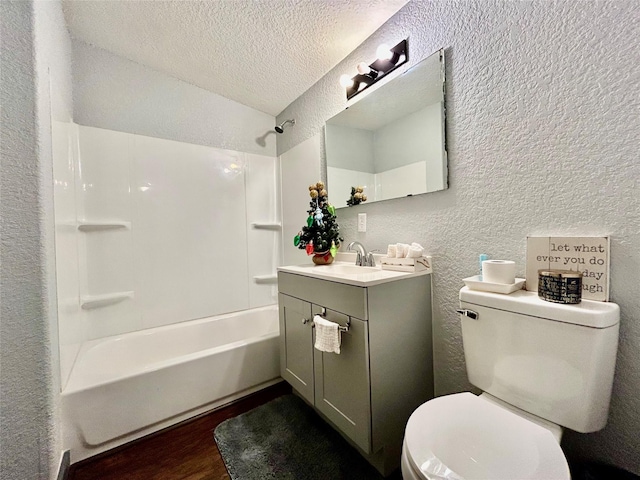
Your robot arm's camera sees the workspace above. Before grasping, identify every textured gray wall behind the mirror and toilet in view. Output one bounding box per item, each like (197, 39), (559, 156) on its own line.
(278, 1), (640, 474)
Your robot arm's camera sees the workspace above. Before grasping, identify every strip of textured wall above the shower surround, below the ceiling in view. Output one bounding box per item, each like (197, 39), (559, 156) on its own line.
(73, 40), (276, 156)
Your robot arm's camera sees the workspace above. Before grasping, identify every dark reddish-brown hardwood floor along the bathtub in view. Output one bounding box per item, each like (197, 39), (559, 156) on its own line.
(69, 382), (291, 480)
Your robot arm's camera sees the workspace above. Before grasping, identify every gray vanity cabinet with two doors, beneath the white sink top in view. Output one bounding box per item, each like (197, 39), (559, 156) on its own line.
(278, 271), (433, 475)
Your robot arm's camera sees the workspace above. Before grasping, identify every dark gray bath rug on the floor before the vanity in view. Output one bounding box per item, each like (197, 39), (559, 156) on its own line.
(214, 395), (382, 480)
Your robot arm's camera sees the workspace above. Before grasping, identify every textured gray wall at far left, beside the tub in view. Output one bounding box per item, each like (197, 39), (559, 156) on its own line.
(0, 2), (71, 480)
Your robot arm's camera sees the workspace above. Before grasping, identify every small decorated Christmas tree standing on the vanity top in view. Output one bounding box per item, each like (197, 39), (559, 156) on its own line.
(293, 182), (342, 260)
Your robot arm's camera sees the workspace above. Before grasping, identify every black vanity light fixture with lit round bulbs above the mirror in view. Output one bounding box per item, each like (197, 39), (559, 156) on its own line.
(340, 39), (409, 100)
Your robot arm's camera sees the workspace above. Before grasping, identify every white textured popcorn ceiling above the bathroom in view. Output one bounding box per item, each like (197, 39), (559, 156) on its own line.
(63, 0), (408, 115)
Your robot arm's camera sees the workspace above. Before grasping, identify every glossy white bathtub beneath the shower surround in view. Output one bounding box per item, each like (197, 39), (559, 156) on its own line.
(62, 305), (280, 462)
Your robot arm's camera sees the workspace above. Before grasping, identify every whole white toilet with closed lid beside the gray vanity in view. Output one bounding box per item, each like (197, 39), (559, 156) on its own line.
(402, 287), (620, 480)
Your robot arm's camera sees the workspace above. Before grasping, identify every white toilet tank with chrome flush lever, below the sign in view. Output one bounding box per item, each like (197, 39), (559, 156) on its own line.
(460, 287), (620, 433)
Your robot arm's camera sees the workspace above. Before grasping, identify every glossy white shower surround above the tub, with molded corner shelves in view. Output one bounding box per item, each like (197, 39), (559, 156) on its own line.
(53, 123), (282, 388)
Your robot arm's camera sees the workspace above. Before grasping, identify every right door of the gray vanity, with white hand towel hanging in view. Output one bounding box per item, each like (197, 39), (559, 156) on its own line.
(313, 305), (371, 453)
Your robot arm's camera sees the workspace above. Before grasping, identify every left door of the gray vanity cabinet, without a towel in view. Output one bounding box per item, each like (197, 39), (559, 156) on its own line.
(278, 294), (313, 404)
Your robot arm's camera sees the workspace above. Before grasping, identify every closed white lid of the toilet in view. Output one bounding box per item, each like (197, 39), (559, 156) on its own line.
(405, 392), (571, 480)
